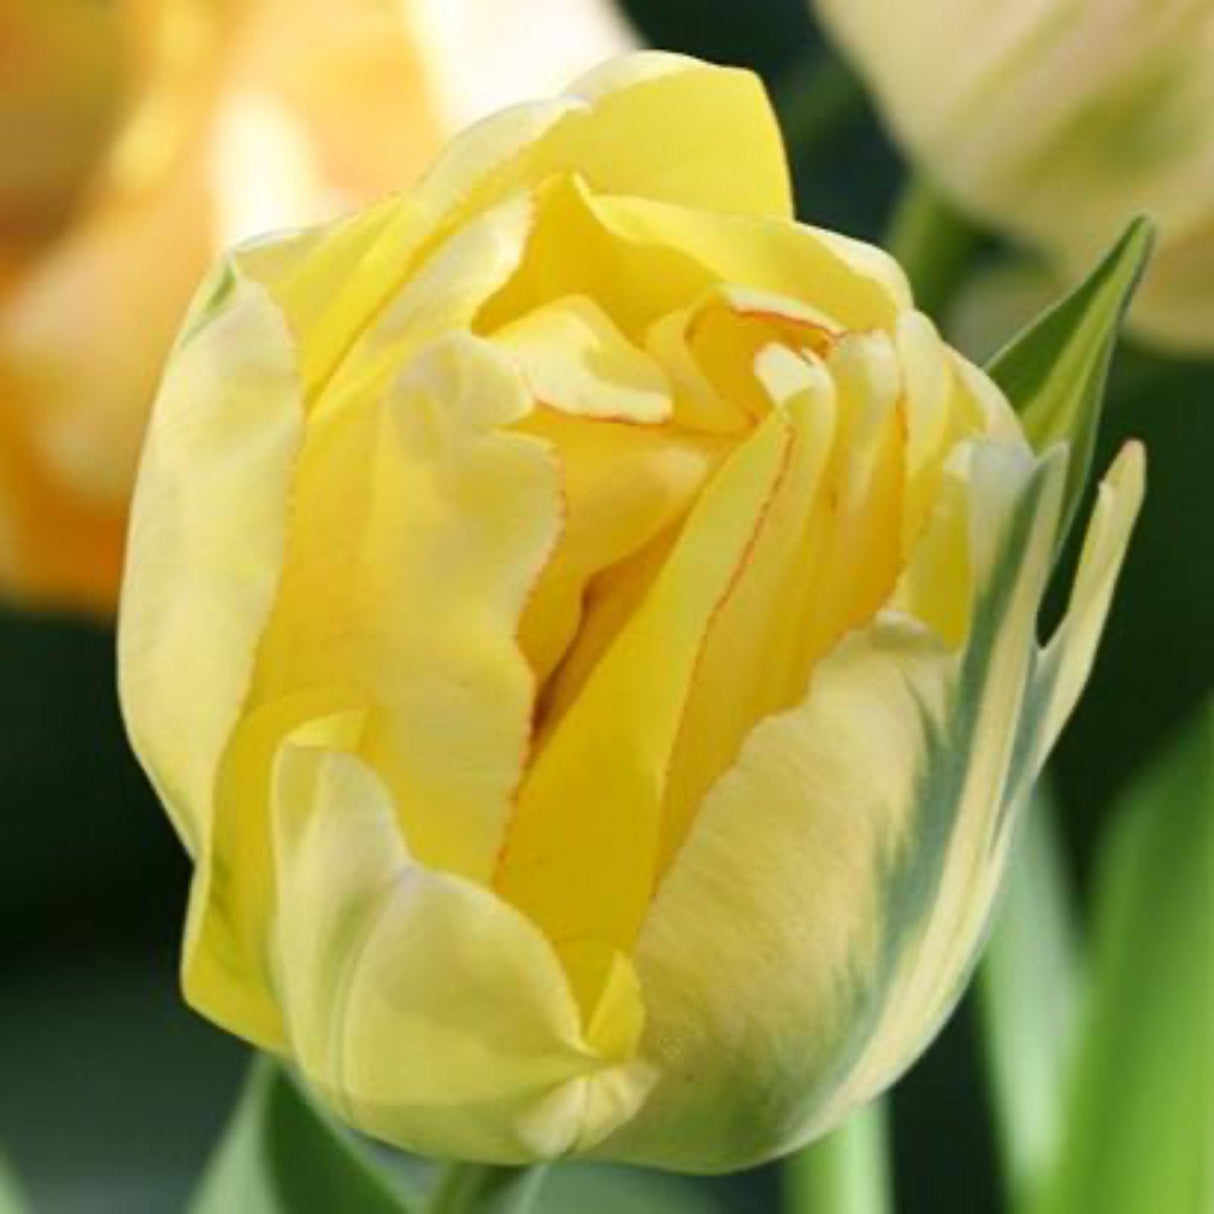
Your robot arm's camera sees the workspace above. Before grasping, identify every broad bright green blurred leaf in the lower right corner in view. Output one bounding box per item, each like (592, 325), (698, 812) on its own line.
(1037, 700), (1214, 1214)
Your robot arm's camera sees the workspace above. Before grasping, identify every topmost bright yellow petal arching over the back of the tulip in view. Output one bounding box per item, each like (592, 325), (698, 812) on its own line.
(269, 52), (792, 390)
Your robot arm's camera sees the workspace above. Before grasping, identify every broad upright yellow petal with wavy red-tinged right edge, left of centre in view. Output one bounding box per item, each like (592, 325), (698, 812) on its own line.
(242, 336), (561, 880)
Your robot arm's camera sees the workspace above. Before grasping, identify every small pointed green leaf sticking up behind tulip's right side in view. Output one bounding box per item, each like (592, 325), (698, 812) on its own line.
(987, 217), (1155, 544)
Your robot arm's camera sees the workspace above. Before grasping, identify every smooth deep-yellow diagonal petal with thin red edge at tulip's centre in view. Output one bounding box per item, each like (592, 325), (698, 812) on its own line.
(494, 413), (790, 1015)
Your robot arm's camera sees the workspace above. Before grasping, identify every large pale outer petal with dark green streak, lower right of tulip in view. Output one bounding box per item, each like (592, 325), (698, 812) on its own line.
(601, 444), (1063, 1170)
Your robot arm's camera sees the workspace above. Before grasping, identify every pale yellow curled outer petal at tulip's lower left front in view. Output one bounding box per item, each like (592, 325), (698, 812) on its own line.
(272, 725), (649, 1163)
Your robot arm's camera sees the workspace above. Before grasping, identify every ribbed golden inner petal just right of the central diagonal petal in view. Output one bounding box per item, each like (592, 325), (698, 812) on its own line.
(658, 334), (903, 878)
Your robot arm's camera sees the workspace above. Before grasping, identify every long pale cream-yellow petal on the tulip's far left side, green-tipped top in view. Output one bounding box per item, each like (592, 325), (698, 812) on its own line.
(118, 260), (304, 852)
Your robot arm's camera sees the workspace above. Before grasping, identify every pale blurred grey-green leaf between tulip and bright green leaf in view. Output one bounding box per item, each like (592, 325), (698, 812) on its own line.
(978, 789), (1082, 1208)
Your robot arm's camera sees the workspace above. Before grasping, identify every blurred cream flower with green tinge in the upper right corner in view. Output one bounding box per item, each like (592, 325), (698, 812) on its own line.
(816, 0), (1214, 353)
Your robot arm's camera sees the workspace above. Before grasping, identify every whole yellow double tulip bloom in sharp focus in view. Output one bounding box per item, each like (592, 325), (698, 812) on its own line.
(120, 53), (1142, 1170)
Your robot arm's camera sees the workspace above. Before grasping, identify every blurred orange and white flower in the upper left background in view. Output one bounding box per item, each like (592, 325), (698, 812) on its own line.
(0, 0), (631, 611)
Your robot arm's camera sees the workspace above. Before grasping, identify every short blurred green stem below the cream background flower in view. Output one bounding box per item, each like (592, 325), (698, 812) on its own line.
(885, 176), (982, 322)
